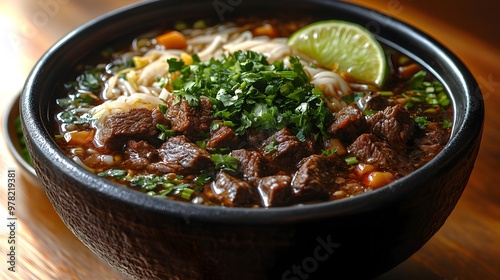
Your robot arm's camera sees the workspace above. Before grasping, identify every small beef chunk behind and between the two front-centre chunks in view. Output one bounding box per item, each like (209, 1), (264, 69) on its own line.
(231, 149), (266, 183)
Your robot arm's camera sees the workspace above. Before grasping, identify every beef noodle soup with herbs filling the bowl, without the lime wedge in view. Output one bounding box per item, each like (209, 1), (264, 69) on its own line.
(54, 18), (453, 207)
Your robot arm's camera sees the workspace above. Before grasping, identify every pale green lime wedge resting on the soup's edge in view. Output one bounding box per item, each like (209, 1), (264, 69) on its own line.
(288, 20), (386, 87)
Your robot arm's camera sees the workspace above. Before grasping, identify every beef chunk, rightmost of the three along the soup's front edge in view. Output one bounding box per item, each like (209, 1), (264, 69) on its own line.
(291, 154), (346, 202)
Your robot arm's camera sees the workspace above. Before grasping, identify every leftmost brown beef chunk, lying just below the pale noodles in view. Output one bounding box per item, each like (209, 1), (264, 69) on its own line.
(101, 109), (168, 151)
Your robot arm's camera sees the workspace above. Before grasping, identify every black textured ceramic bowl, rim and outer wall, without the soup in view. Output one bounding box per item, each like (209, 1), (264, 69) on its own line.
(21, 0), (484, 279)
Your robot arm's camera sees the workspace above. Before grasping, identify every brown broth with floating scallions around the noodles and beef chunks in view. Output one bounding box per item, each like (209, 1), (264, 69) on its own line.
(54, 18), (453, 207)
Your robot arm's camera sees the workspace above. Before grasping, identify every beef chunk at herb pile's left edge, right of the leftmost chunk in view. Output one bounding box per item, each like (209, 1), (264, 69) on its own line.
(165, 98), (212, 141)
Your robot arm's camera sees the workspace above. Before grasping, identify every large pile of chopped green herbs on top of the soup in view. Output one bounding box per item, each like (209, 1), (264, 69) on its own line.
(168, 51), (333, 141)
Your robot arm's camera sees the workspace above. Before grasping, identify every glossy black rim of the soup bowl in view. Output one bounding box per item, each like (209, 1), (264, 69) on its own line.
(21, 0), (484, 224)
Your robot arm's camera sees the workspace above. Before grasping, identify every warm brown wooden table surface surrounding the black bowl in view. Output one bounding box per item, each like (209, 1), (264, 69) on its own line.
(0, 0), (500, 280)
